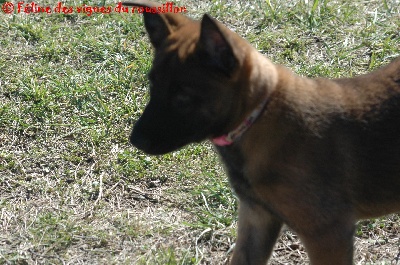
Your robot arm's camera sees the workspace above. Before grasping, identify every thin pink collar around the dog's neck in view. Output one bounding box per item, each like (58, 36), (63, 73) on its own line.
(211, 99), (268, 146)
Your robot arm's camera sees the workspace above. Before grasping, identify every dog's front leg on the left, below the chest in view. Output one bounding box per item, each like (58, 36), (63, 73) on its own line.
(230, 200), (282, 265)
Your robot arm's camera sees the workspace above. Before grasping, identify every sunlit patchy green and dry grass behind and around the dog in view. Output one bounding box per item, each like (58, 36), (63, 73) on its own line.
(0, 0), (400, 264)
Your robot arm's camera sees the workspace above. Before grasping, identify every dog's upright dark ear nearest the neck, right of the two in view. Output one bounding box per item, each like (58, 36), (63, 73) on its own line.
(199, 14), (238, 76)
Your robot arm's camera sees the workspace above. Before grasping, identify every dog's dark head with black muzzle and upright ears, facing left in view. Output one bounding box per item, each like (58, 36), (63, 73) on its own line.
(123, 1), (260, 154)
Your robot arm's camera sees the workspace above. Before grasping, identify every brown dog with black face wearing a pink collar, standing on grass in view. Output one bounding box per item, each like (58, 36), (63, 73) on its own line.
(123, 1), (400, 265)
